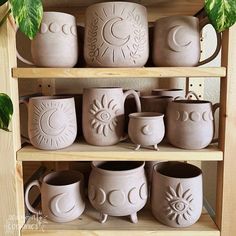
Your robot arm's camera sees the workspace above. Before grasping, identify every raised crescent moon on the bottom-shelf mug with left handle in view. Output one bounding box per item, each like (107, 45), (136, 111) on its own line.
(50, 193), (76, 218)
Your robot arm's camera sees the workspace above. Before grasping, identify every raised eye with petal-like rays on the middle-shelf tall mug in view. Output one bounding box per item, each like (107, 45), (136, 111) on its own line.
(90, 95), (119, 136)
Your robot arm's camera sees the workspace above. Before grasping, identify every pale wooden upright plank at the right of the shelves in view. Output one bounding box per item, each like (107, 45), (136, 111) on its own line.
(216, 25), (236, 236)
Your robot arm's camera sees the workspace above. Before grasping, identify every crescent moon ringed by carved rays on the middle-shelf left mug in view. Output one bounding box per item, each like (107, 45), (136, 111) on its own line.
(39, 109), (66, 136)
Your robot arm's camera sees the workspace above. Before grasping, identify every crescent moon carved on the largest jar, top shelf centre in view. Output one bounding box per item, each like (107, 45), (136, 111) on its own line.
(103, 17), (130, 46)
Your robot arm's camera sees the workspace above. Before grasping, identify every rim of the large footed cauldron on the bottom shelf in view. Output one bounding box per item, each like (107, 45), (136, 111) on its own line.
(91, 161), (145, 176)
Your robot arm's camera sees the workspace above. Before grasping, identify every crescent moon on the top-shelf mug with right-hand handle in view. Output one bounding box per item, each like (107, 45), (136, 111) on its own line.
(167, 25), (192, 52)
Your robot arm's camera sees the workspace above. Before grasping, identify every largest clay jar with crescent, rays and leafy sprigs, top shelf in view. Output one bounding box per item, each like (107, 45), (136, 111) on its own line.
(84, 2), (149, 67)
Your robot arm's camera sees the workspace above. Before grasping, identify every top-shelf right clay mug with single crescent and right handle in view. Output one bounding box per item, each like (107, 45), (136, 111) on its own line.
(153, 16), (221, 66)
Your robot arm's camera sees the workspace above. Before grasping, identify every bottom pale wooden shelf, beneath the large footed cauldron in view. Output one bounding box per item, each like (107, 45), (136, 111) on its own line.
(21, 206), (220, 236)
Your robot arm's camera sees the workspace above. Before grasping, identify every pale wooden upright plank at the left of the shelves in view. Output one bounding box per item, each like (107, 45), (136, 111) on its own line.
(0, 4), (24, 236)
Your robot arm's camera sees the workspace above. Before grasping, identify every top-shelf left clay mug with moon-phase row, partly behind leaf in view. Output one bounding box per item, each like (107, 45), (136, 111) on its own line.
(17, 12), (78, 67)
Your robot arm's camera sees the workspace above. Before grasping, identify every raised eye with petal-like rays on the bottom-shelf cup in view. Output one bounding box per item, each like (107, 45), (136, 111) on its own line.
(166, 183), (193, 225)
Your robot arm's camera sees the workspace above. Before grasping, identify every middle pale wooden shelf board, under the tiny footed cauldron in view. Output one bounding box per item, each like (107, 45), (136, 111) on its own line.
(17, 142), (223, 161)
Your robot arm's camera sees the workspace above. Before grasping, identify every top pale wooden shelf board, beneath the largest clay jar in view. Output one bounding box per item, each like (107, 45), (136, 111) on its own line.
(12, 67), (226, 79)
